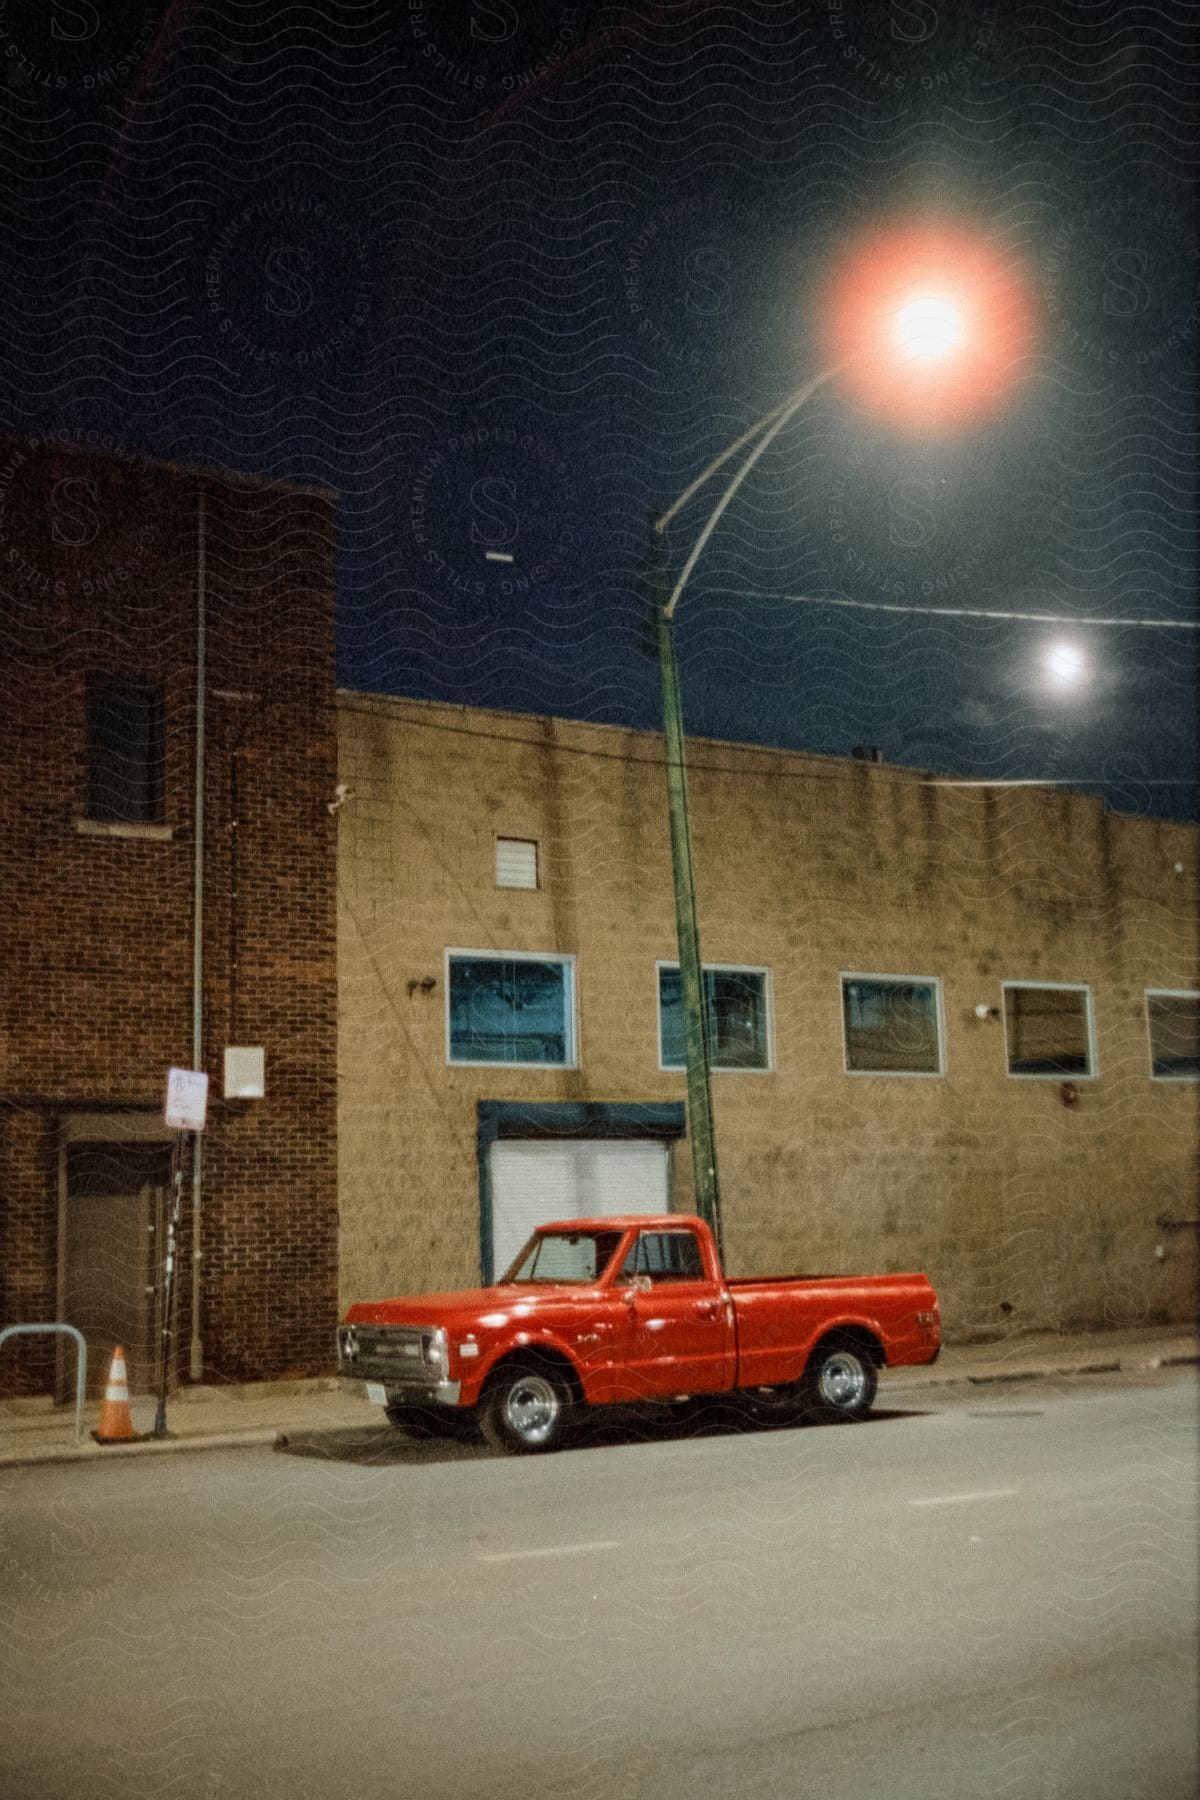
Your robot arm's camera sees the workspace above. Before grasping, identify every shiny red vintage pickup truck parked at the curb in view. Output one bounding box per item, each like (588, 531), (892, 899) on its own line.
(338, 1213), (941, 1453)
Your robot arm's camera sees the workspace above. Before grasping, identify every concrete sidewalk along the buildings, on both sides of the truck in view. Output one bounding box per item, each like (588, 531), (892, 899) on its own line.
(0, 1327), (1200, 1469)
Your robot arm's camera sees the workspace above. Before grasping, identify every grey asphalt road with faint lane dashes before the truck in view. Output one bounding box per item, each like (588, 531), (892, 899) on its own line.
(0, 1372), (1200, 1800)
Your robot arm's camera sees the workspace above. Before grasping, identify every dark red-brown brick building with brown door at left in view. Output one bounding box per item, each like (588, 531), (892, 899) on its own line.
(0, 441), (336, 1391)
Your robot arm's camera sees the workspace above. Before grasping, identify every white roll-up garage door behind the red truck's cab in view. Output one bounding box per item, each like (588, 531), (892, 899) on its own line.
(486, 1138), (669, 1280)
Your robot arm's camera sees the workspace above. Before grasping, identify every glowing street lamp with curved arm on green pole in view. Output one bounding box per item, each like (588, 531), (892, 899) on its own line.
(648, 223), (1031, 1247)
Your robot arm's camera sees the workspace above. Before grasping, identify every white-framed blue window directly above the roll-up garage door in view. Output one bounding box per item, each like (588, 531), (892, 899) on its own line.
(446, 950), (576, 1069)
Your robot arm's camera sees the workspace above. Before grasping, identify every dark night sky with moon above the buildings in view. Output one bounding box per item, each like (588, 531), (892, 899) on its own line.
(0, 0), (1196, 817)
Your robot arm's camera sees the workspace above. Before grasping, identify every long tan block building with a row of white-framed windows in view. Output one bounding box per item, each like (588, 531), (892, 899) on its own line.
(338, 693), (1200, 1337)
